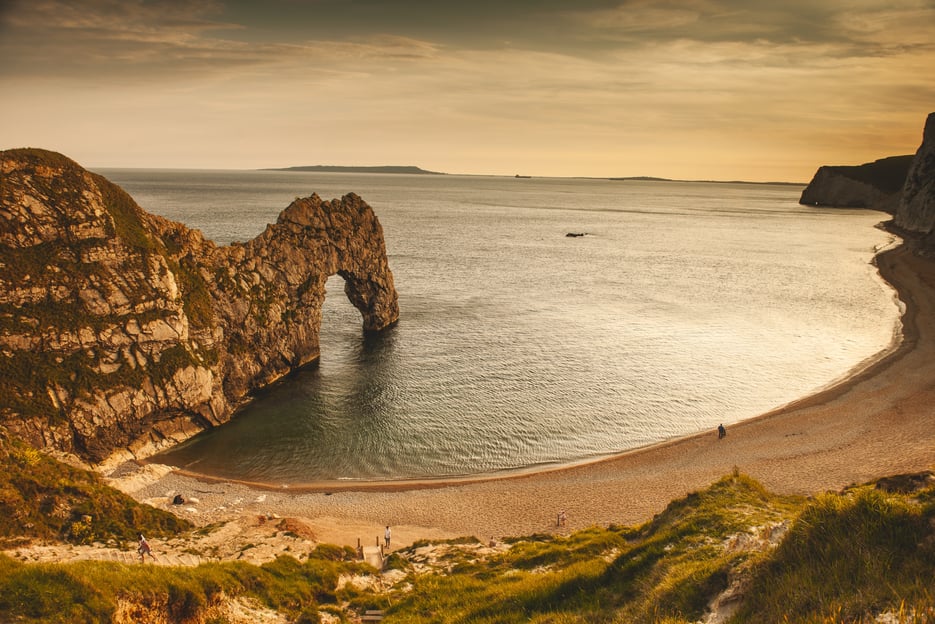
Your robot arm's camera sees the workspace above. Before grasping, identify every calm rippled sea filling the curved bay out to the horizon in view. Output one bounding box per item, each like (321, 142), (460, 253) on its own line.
(100, 169), (900, 487)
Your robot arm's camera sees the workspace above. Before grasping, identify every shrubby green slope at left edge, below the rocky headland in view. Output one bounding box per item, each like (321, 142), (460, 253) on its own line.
(0, 436), (191, 545)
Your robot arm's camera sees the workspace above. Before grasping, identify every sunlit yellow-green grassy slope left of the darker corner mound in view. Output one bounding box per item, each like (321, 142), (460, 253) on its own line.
(386, 474), (801, 624)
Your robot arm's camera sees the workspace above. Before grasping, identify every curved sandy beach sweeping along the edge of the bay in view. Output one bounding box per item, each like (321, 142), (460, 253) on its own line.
(119, 234), (935, 547)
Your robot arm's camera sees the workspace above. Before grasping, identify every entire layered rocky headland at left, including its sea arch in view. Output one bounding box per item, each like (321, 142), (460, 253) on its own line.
(0, 149), (399, 463)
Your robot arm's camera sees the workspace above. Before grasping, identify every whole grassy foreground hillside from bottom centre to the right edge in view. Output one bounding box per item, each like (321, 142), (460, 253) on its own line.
(374, 472), (935, 624)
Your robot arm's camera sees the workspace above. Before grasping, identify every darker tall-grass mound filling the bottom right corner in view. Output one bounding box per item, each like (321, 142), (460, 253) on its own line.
(735, 486), (935, 622)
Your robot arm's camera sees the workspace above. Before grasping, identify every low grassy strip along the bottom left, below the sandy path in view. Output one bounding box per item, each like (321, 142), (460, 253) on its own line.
(0, 553), (376, 624)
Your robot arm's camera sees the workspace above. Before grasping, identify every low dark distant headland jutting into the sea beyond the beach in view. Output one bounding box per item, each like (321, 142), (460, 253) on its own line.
(799, 155), (912, 214)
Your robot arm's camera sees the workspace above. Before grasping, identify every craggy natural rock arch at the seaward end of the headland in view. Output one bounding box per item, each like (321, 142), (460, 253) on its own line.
(219, 193), (399, 398)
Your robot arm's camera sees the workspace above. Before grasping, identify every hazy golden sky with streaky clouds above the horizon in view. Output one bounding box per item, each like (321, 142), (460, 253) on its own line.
(0, 0), (935, 182)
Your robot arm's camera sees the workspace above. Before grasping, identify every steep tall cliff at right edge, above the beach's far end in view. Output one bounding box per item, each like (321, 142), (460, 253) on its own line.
(894, 113), (935, 235)
